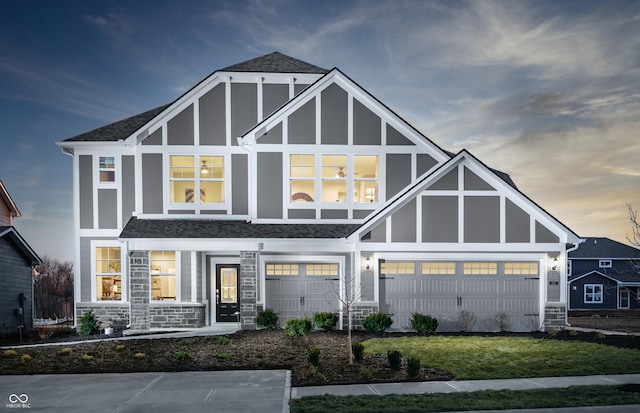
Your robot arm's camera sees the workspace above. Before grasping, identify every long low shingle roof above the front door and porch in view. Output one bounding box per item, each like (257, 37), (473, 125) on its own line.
(120, 217), (359, 239)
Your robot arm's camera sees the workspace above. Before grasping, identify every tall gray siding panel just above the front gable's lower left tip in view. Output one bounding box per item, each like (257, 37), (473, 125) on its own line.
(231, 83), (258, 145)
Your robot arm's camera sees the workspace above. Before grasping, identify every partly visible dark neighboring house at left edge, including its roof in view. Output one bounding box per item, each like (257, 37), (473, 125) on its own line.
(0, 181), (42, 334)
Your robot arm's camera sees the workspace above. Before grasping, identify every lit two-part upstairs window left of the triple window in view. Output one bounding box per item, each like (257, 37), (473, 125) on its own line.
(169, 155), (225, 204)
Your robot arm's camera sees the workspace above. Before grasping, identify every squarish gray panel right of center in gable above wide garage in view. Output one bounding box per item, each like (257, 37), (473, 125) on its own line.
(464, 196), (500, 242)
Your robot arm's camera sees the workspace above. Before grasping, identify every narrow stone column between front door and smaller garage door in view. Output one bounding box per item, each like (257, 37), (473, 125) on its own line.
(240, 251), (258, 330)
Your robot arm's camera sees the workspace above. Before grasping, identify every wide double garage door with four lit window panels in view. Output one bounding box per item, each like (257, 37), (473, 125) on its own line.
(380, 261), (539, 331)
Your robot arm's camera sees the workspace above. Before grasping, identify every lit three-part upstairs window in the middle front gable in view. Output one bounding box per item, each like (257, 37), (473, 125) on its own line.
(289, 154), (380, 203)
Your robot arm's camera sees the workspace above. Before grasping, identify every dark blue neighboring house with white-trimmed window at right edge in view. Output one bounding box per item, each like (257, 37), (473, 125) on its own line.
(567, 238), (640, 310)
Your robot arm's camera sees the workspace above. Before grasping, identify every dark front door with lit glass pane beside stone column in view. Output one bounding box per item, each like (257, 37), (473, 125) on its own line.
(216, 264), (240, 323)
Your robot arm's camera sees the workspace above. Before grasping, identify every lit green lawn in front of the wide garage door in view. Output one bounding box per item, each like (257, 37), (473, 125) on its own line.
(364, 336), (640, 380)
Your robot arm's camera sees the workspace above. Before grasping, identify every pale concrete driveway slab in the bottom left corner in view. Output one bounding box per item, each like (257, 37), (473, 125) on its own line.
(0, 370), (291, 413)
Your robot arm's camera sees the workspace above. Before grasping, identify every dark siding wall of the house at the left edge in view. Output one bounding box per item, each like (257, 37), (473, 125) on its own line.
(0, 235), (33, 334)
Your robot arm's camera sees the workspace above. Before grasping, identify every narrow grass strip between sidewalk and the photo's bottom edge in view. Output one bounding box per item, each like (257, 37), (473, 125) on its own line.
(290, 386), (640, 413)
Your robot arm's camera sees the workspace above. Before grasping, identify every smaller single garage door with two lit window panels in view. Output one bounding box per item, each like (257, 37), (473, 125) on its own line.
(265, 263), (340, 325)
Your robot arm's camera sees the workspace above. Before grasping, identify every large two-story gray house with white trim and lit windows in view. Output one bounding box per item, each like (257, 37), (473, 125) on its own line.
(58, 52), (580, 331)
